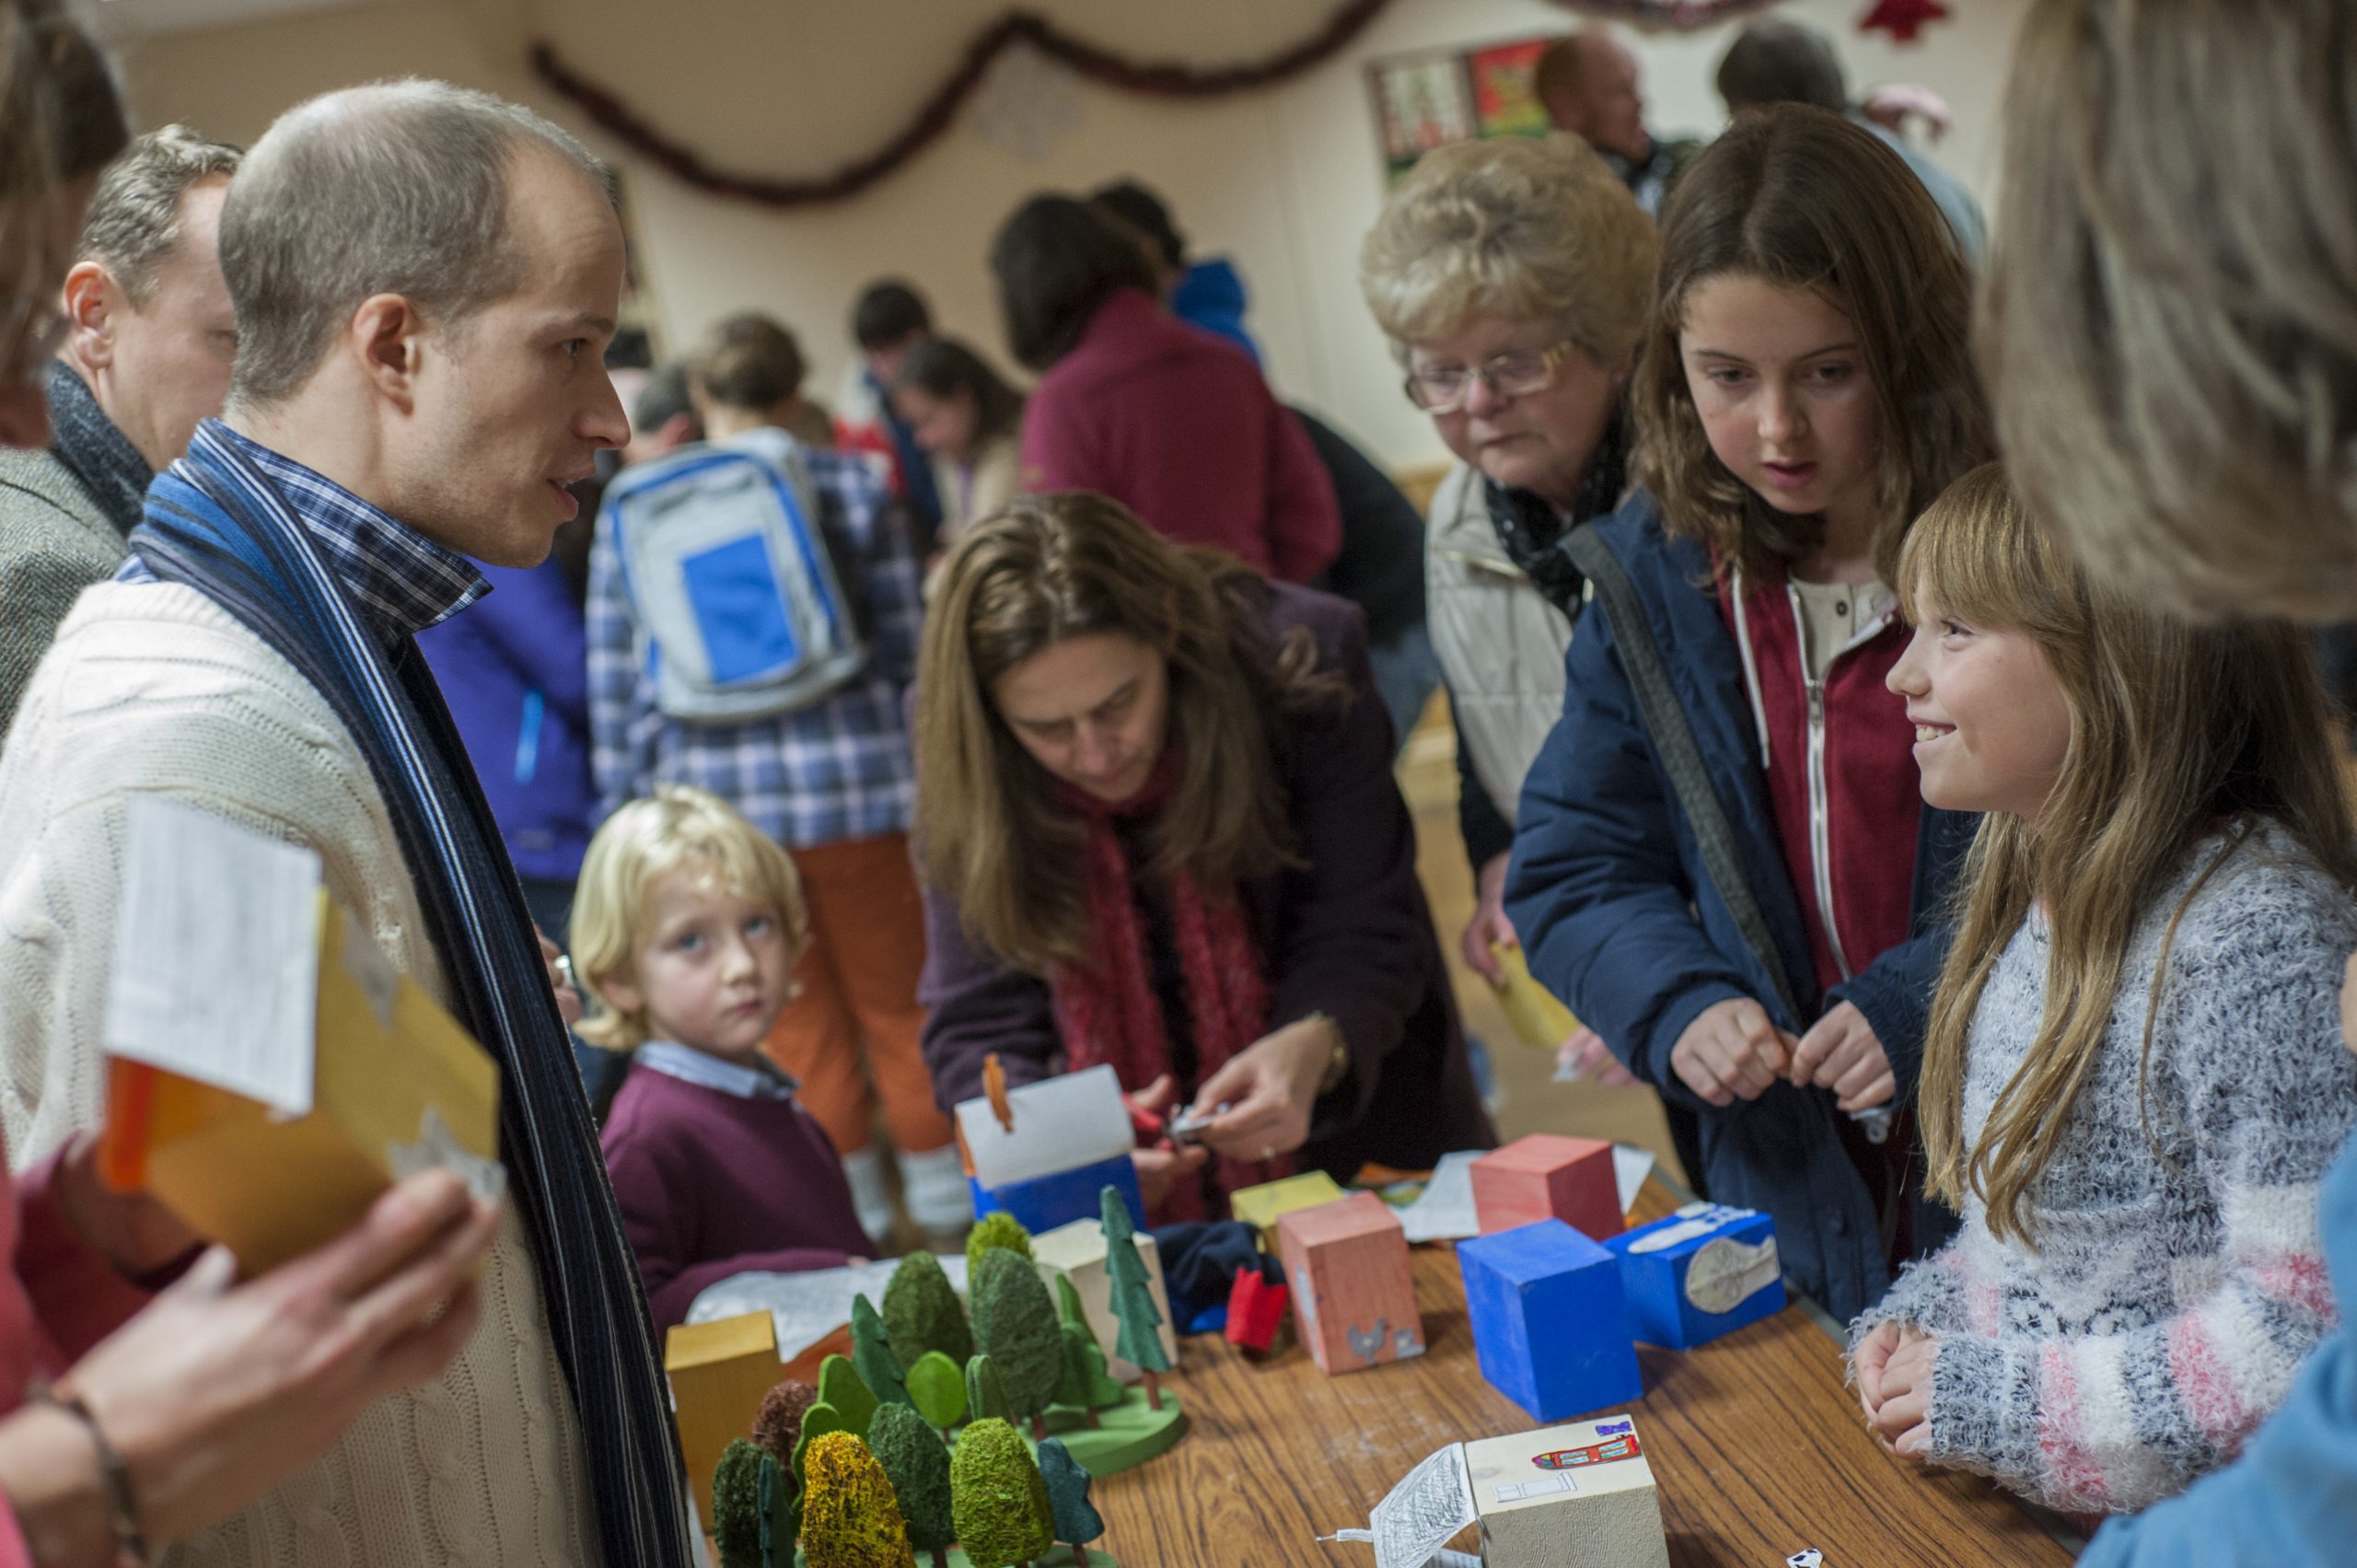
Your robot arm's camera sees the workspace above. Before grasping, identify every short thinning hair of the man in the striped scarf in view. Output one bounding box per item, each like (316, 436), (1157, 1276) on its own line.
(222, 80), (613, 408)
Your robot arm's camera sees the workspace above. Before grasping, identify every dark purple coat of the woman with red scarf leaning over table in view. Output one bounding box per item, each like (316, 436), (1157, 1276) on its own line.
(917, 585), (1497, 1181)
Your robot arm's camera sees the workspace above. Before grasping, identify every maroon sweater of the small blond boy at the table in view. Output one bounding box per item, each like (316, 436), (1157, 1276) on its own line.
(598, 1066), (875, 1328)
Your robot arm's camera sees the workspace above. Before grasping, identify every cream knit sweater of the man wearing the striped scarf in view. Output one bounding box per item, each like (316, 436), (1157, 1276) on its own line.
(0, 583), (598, 1568)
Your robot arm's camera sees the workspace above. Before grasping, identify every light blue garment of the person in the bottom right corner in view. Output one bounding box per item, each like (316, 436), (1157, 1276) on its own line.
(2079, 1144), (2357, 1568)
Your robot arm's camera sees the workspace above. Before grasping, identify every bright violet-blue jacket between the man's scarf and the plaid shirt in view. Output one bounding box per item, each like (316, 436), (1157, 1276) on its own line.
(417, 559), (597, 882)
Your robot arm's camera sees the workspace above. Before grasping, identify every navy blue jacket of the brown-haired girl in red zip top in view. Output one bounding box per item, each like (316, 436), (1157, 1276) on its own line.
(1506, 491), (1978, 1320)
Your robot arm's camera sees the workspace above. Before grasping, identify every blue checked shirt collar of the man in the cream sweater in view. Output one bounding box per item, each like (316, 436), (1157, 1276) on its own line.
(121, 420), (490, 646)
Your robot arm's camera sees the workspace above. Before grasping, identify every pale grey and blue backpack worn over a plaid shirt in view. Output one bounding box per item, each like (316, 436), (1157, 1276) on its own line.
(601, 429), (867, 724)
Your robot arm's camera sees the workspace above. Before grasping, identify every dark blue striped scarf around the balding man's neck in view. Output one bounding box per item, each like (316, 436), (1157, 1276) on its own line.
(132, 422), (695, 1568)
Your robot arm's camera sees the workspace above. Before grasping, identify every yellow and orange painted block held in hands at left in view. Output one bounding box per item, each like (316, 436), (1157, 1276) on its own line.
(109, 894), (502, 1273)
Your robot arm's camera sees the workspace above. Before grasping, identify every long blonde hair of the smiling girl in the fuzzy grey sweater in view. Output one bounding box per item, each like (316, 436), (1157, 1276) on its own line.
(1893, 464), (2357, 1240)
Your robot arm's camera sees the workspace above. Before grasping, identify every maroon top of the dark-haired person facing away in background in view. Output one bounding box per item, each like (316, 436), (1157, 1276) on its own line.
(1023, 287), (1341, 583)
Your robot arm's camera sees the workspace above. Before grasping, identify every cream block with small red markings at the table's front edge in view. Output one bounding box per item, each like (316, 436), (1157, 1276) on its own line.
(1466, 1415), (1668, 1568)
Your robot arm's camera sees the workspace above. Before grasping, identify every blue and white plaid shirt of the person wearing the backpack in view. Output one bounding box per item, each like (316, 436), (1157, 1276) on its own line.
(586, 450), (924, 849)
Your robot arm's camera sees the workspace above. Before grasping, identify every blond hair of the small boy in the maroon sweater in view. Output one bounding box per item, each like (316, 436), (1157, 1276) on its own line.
(573, 785), (811, 1051)
